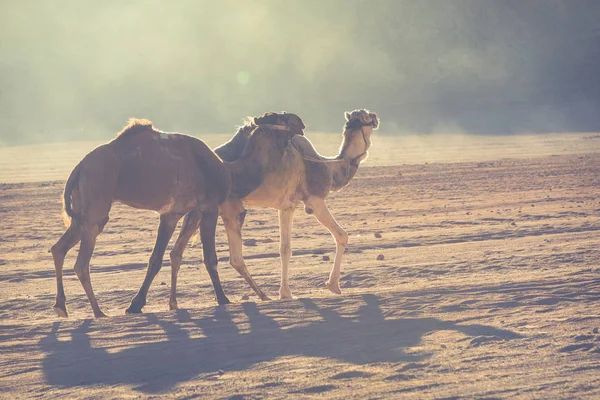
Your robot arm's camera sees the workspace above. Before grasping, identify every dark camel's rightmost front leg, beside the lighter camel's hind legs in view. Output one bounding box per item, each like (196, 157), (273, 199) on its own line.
(200, 210), (231, 304)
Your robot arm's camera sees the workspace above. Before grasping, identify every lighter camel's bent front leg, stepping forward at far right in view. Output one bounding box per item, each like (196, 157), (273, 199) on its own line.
(306, 197), (348, 294)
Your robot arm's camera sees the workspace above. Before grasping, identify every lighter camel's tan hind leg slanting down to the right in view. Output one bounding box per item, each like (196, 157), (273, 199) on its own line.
(220, 201), (270, 300)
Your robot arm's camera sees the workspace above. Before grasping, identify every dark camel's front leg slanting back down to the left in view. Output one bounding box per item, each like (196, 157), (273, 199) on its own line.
(125, 214), (181, 314)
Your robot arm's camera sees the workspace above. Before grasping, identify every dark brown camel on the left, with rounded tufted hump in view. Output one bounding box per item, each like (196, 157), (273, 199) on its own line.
(50, 114), (304, 318)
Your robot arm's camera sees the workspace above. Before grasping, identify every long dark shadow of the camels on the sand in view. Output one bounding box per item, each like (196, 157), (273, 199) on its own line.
(40, 295), (520, 393)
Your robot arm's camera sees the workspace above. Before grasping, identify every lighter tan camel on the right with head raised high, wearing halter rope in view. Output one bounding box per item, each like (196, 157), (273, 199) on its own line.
(169, 110), (379, 309)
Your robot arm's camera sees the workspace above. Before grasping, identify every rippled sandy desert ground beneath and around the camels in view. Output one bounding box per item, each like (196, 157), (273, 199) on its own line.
(0, 134), (600, 399)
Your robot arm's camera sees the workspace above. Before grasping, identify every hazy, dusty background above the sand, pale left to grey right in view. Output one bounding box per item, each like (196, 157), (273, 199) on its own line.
(0, 0), (600, 144)
